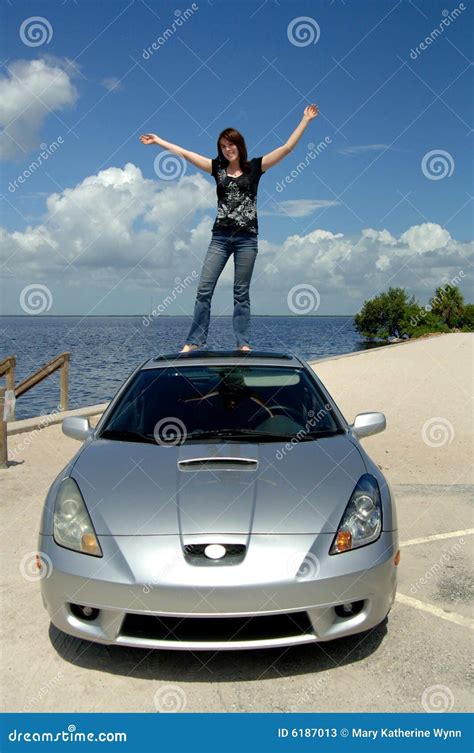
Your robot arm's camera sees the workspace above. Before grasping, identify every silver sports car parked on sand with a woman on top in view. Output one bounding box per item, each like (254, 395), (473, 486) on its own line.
(37, 350), (399, 651)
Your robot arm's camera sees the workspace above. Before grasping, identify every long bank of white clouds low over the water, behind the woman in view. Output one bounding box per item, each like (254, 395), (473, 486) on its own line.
(0, 162), (473, 314)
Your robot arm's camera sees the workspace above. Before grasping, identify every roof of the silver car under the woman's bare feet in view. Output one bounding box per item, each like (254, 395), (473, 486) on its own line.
(142, 350), (305, 369)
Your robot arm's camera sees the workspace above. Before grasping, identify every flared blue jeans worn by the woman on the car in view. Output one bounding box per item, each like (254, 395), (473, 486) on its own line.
(186, 231), (258, 348)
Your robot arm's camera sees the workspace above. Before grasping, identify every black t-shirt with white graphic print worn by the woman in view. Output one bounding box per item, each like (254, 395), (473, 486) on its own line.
(212, 157), (265, 235)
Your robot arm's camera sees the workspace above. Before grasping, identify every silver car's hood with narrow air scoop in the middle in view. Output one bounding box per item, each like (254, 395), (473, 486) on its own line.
(71, 434), (366, 536)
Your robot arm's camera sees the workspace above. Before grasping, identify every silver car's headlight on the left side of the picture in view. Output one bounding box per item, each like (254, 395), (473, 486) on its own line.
(53, 478), (102, 557)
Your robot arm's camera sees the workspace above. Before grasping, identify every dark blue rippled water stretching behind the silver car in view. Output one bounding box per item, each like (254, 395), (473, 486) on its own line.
(0, 316), (376, 419)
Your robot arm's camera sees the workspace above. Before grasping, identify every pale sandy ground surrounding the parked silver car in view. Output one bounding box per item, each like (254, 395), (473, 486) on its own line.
(0, 333), (474, 712)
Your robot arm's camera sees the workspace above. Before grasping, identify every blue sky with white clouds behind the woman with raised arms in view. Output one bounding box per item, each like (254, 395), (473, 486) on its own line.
(0, 0), (473, 315)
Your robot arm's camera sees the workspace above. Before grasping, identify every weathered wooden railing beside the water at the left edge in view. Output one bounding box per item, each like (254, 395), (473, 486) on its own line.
(0, 353), (71, 468)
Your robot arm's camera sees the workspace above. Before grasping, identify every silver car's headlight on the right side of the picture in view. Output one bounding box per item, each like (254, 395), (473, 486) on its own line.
(329, 473), (382, 554)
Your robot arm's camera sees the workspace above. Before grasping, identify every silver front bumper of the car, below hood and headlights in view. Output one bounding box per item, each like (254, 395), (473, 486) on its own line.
(39, 531), (398, 651)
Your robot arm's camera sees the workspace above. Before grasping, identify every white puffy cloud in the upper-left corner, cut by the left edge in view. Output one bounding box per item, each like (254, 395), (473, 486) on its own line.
(0, 60), (78, 159)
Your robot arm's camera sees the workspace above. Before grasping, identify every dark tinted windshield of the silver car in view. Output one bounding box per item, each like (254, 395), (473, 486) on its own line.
(100, 366), (344, 444)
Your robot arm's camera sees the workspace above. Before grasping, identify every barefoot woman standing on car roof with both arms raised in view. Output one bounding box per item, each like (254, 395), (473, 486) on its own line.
(140, 104), (319, 353)
